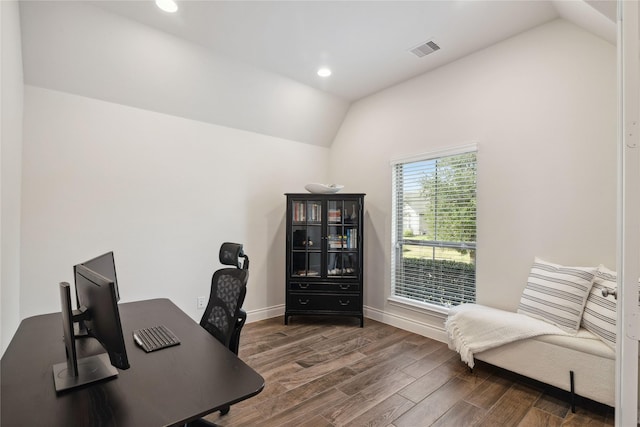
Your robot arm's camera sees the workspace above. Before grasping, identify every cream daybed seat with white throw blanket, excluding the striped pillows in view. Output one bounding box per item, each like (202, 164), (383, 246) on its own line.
(445, 304), (615, 409)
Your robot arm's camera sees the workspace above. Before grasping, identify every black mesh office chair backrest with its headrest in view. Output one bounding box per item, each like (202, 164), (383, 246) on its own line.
(200, 243), (249, 347)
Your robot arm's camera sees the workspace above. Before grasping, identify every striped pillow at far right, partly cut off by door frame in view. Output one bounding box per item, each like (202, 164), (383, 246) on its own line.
(582, 265), (618, 350)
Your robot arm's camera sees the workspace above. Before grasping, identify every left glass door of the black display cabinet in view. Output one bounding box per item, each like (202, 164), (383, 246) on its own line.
(290, 200), (322, 277)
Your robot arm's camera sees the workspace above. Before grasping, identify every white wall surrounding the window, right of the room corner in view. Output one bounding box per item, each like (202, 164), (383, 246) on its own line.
(330, 20), (616, 338)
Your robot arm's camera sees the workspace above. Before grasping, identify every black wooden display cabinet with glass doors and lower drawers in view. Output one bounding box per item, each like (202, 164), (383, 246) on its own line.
(284, 193), (365, 327)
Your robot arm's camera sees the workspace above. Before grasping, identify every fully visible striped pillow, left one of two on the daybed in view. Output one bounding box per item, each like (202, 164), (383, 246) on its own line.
(518, 258), (596, 333)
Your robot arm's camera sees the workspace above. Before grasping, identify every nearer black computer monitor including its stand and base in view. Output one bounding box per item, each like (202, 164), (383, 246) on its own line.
(53, 265), (129, 392)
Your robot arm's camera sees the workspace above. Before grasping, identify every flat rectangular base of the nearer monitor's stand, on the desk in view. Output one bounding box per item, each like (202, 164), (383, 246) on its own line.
(53, 353), (118, 392)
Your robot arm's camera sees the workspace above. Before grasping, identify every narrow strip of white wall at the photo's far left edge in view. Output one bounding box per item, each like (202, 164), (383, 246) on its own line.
(0, 1), (23, 354)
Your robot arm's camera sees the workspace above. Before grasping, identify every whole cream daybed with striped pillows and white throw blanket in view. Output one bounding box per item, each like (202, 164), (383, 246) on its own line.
(445, 257), (640, 412)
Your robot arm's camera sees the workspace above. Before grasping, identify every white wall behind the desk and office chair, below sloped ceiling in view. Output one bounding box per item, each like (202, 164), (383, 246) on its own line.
(20, 85), (328, 320)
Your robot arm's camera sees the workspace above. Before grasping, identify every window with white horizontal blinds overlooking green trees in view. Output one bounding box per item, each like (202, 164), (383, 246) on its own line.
(391, 145), (477, 307)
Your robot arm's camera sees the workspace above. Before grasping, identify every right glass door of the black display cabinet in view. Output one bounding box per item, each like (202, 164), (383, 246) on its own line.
(324, 200), (360, 277)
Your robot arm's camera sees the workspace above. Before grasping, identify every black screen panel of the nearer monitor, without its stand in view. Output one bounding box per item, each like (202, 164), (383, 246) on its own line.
(75, 265), (129, 369)
